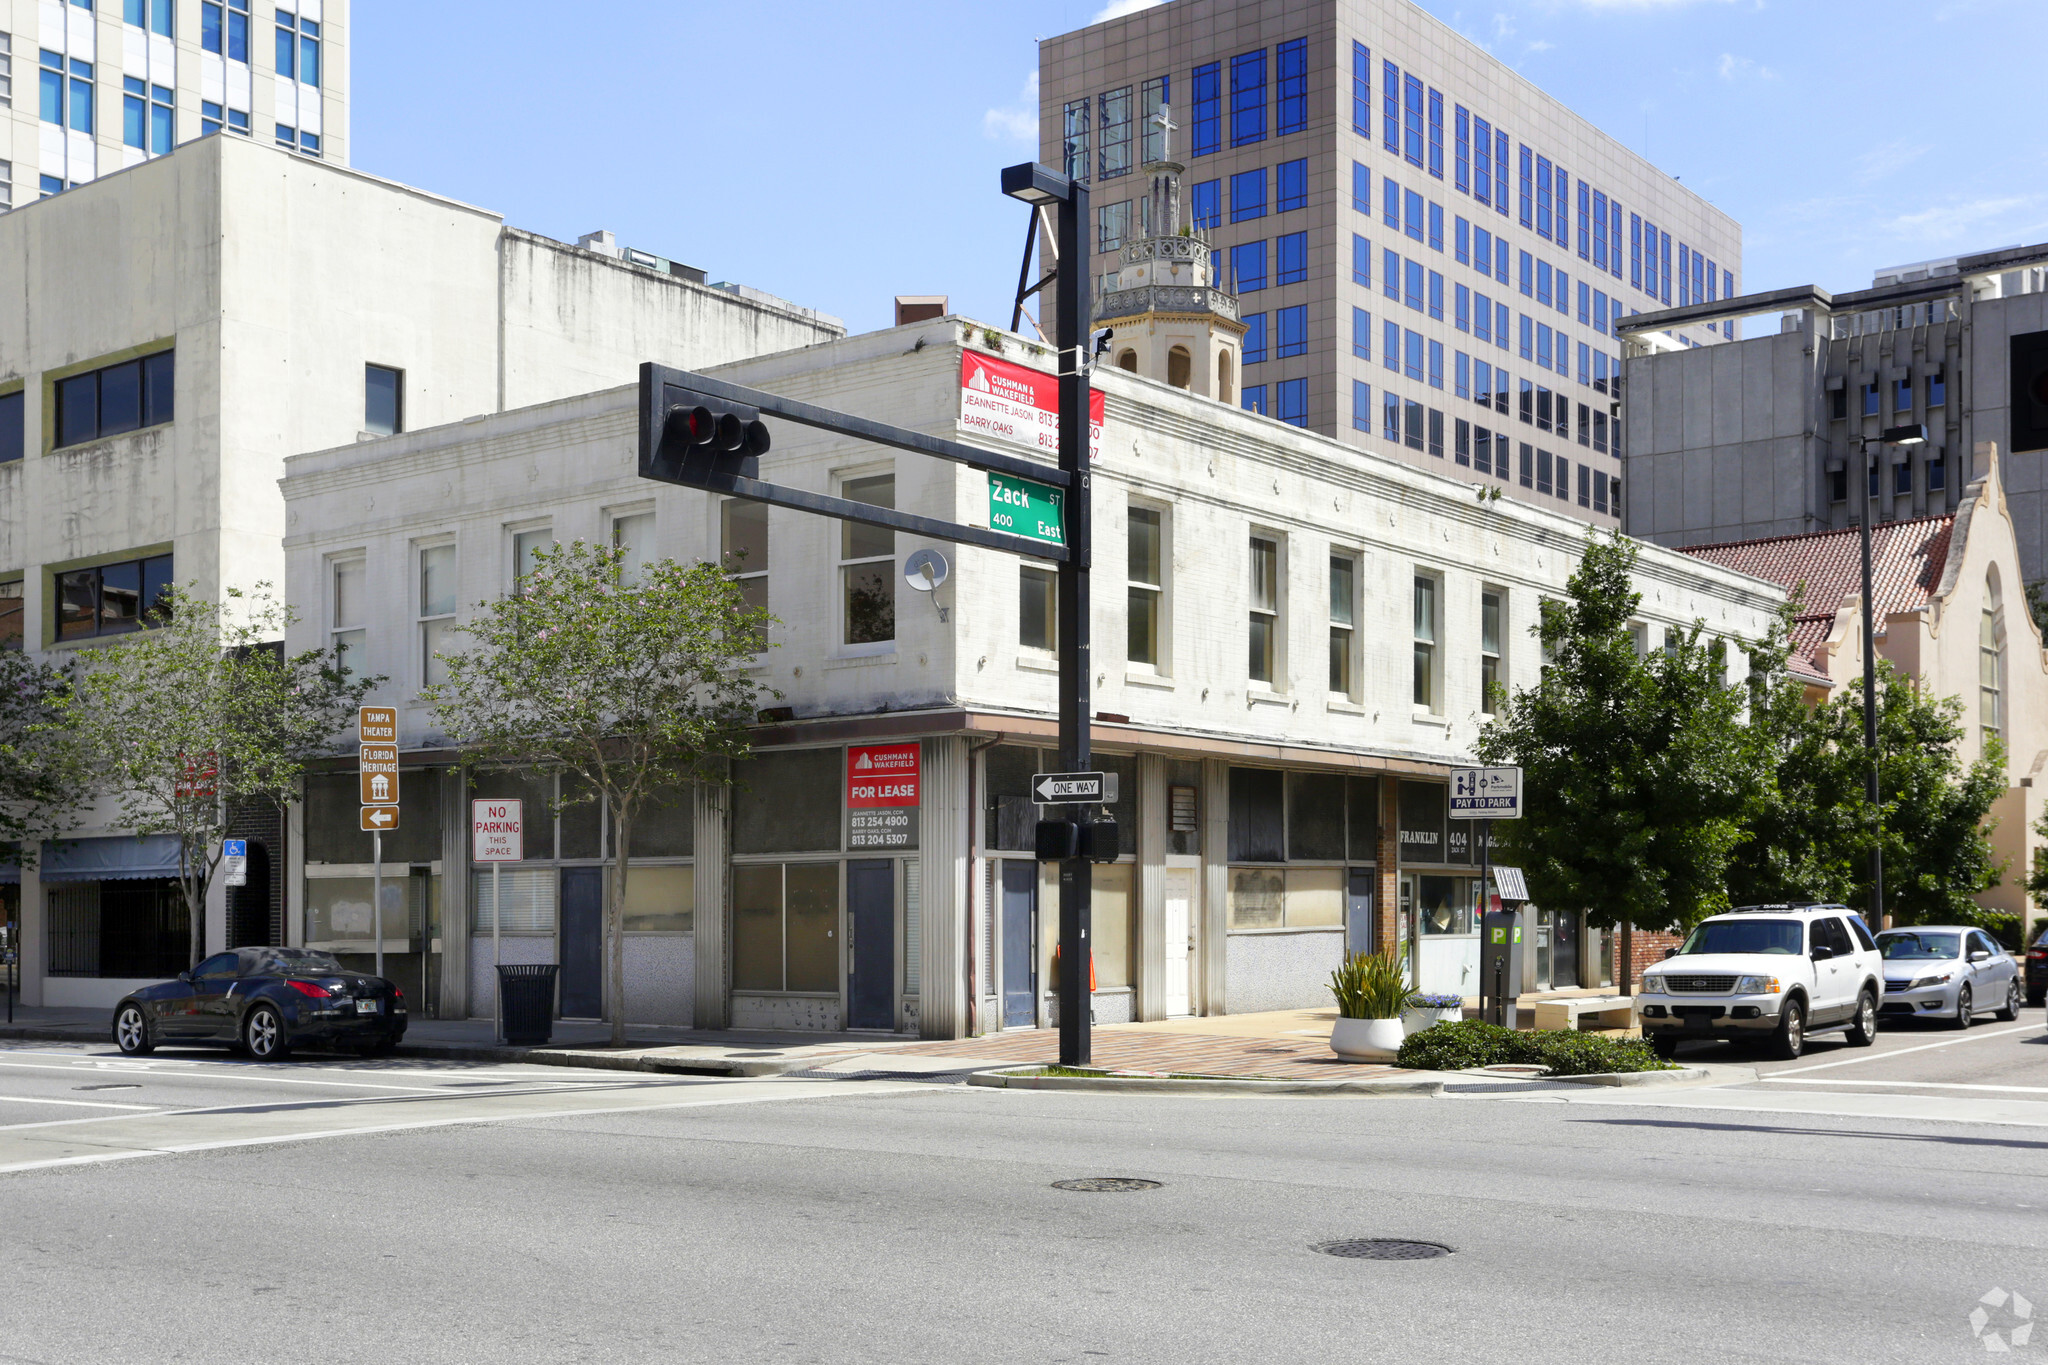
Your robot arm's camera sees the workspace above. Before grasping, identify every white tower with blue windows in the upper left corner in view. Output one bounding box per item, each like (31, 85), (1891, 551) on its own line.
(0, 0), (348, 211)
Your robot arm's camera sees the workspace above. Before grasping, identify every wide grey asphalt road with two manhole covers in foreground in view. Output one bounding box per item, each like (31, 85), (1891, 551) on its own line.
(0, 1035), (2048, 1365)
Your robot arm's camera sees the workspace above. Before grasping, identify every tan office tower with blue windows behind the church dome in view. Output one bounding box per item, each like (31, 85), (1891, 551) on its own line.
(1038, 0), (1743, 526)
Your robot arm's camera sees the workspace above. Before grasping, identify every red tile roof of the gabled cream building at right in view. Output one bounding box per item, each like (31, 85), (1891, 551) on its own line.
(1679, 516), (1956, 677)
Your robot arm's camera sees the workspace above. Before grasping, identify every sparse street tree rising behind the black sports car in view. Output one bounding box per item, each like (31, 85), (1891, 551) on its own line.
(57, 583), (383, 966)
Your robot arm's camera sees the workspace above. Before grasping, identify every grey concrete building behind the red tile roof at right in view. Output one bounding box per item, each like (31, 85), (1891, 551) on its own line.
(1622, 244), (2048, 583)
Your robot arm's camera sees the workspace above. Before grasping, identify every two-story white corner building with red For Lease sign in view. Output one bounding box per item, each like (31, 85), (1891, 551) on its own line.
(283, 317), (1784, 1038)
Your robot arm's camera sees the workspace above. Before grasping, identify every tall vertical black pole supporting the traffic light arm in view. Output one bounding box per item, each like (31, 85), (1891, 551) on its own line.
(1055, 180), (1094, 1066)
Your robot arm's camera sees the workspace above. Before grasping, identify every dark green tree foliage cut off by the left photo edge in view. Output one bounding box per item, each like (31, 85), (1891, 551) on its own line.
(0, 649), (84, 864)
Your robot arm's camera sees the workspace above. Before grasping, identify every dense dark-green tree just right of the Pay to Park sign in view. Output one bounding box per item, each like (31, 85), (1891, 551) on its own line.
(1475, 534), (1757, 929)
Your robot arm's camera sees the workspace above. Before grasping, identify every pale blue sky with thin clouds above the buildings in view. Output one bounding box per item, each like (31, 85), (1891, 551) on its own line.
(350, 0), (2048, 332)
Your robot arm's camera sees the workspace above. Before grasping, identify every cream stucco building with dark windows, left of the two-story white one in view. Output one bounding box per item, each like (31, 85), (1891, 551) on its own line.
(0, 133), (844, 1005)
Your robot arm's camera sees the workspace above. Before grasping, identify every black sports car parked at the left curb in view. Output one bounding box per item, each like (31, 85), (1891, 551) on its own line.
(115, 948), (406, 1062)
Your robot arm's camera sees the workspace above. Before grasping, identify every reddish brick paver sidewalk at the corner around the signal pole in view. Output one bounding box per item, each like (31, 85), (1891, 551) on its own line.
(889, 1025), (1407, 1081)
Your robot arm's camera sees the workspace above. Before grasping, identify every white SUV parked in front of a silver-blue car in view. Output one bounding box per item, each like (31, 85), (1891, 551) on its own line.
(1636, 905), (1884, 1058)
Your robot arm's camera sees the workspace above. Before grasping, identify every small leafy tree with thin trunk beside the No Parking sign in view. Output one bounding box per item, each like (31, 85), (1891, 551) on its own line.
(422, 540), (772, 1044)
